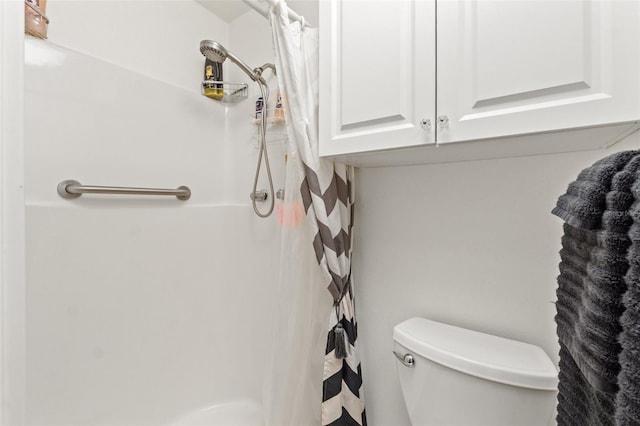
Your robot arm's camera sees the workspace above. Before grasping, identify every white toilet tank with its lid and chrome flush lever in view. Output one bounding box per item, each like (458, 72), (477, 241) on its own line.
(393, 318), (558, 426)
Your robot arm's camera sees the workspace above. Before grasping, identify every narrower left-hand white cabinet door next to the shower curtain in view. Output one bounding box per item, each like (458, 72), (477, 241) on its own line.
(319, 0), (435, 156)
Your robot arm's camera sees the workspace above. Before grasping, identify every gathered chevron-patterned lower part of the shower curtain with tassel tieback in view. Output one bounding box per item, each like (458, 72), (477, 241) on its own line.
(300, 161), (367, 426)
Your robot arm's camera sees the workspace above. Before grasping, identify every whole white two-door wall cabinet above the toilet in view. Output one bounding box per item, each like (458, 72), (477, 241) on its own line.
(319, 0), (640, 164)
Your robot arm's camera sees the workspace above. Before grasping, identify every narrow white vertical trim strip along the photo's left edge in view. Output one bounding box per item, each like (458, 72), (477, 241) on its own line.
(0, 2), (25, 424)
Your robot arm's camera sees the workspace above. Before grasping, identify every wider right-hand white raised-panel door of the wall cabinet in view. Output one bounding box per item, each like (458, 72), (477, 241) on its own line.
(436, 0), (640, 142)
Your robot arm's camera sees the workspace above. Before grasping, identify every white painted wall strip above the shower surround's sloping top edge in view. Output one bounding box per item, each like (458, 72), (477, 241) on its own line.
(47, 0), (229, 92)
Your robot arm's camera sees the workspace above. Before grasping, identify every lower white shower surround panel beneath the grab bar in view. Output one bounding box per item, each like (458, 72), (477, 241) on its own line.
(27, 205), (278, 425)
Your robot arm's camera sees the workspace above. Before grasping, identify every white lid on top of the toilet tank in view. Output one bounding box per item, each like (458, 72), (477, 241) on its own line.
(393, 318), (558, 390)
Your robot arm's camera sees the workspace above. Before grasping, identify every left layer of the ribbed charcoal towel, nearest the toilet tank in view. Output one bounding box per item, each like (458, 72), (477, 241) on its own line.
(553, 151), (640, 425)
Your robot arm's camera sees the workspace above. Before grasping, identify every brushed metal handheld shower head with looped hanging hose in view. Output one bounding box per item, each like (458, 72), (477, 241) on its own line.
(200, 40), (276, 218)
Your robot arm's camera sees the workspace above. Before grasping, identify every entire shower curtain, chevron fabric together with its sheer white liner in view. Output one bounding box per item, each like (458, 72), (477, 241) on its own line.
(265, 0), (366, 426)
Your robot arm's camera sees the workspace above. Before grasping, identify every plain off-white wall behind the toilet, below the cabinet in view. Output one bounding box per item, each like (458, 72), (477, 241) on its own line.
(354, 133), (640, 426)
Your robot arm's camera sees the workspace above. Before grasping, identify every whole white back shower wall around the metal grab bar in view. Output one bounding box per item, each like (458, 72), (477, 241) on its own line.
(25, 0), (281, 425)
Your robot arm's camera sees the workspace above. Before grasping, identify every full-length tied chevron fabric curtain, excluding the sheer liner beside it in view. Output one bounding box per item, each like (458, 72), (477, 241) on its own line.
(269, 0), (367, 426)
